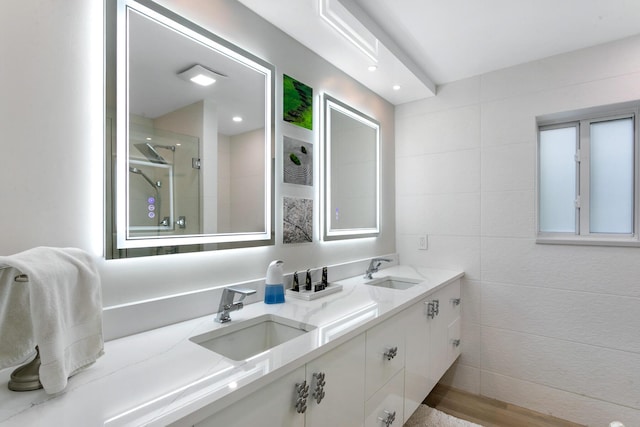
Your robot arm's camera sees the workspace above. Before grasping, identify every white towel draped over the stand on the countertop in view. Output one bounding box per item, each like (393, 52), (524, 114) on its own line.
(0, 247), (104, 394)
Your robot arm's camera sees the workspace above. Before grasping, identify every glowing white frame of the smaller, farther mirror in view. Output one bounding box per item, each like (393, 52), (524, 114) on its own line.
(321, 93), (380, 240)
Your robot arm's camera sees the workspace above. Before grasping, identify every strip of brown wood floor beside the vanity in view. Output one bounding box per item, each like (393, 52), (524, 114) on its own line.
(423, 384), (584, 427)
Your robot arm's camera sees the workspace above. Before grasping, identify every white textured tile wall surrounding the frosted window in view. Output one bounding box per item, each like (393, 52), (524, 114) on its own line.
(396, 37), (640, 426)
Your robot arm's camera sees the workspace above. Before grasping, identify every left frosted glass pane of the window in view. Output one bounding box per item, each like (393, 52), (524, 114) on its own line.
(539, 127), (577, 233)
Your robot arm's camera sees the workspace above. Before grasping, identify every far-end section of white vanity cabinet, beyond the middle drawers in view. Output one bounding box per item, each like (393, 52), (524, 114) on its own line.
(404, 280), (460, 418)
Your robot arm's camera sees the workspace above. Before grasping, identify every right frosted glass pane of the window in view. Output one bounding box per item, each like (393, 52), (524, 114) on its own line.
(589, 118), (633, 234)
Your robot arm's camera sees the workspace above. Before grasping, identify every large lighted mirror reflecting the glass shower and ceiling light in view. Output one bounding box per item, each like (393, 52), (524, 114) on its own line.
(107, 0), (274, 258)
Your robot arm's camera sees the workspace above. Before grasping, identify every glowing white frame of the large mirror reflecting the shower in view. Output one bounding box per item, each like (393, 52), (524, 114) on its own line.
(114, 0), (275, 252)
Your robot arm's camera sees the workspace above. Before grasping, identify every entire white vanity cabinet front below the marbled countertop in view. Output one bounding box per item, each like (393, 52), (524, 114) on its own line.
(186, 280), (460, 427)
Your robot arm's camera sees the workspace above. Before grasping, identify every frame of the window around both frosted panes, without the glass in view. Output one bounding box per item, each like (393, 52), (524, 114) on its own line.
(535, 101), (640, 247)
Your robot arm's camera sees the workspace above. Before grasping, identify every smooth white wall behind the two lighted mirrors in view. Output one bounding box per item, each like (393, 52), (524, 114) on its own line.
(0, 0), (395, 311)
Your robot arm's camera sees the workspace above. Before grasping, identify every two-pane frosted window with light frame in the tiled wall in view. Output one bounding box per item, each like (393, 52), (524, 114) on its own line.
(538, 105), (640, 246)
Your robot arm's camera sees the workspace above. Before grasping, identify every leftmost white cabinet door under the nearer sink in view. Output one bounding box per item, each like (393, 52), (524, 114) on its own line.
(195, 367), (305, 427)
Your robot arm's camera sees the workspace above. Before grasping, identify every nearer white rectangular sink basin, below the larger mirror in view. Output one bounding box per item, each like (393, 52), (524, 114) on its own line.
(190, 314), (316, 361)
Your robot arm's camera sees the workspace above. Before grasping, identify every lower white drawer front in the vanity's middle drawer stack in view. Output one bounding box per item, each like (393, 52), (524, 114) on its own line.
(365, 370), (405, 427)
